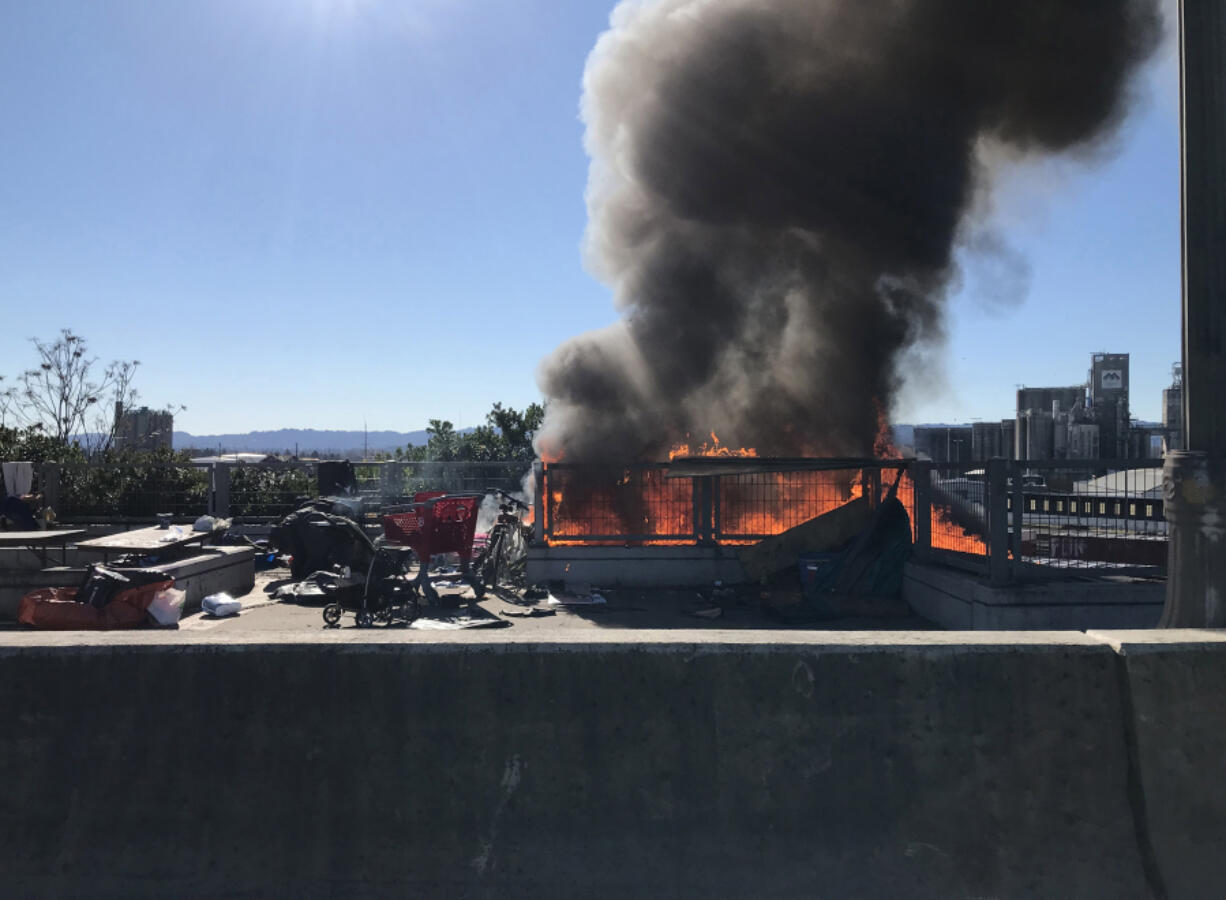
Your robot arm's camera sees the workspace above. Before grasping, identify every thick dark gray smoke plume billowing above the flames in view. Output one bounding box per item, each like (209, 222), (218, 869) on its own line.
(538, 0), (1161, 461)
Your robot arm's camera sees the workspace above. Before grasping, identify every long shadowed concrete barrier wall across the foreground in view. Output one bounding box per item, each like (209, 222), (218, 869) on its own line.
(0, 633), (1226, 900)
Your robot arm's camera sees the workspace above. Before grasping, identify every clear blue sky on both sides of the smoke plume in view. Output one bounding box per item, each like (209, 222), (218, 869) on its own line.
(0, 0), (1179, 434)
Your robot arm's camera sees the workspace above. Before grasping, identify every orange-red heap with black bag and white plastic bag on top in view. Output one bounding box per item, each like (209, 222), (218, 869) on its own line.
(17, 564), (174, 630)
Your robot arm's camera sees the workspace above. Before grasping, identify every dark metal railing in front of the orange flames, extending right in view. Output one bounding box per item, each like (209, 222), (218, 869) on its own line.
(536, 459), (1167, 585)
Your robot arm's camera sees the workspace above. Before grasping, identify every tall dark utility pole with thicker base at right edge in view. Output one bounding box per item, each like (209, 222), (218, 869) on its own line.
(1162, 0), (1226, 628)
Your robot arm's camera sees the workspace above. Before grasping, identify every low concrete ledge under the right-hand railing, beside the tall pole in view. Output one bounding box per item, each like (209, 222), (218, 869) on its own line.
(902, 560), (1166, 630)
